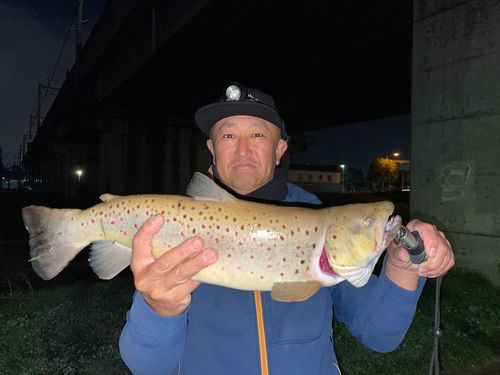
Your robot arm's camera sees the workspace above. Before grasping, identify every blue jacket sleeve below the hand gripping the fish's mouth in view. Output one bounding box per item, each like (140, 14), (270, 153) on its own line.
(330, 259), (426, 353)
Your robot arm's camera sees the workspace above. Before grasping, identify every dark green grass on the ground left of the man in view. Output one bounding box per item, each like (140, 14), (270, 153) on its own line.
(0, 278), (134, 375)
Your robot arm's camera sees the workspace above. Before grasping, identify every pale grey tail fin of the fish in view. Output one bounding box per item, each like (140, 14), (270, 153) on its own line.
(22, 206), (90, 280)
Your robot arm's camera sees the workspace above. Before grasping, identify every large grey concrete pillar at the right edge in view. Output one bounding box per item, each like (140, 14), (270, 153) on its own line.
(411, 0), (500, 284)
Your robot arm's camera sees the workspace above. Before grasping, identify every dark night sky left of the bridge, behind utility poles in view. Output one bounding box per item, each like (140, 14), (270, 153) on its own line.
(0, 0), (106, 167)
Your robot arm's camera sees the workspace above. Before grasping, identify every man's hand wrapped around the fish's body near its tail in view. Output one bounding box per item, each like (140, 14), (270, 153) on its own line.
(130, 215), (217, 317)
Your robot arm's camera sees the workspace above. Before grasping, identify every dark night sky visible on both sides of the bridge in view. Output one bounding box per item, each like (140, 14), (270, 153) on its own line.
(0, 0), (410, 174)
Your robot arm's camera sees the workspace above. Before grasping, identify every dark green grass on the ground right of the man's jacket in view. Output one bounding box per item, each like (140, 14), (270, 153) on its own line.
(334, 269), (500, 375)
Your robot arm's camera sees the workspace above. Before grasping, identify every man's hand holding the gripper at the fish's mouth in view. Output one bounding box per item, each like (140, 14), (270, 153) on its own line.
(385, 220), (455, 290)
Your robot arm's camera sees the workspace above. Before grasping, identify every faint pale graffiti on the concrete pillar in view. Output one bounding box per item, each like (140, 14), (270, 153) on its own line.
(439, 161), (472, 202)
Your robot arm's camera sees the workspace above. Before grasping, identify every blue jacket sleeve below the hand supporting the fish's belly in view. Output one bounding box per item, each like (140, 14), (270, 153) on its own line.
(120, 291), (189, 374)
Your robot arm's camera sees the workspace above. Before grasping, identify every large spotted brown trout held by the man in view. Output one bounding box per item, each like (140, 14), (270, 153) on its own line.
(22, 172), (401, 302)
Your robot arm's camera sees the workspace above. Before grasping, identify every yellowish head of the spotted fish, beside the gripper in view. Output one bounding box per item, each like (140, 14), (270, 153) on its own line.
(325, 201), (401, 287)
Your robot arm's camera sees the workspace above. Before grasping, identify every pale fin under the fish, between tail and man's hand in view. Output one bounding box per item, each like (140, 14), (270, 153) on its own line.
(89, 240), (132, 280)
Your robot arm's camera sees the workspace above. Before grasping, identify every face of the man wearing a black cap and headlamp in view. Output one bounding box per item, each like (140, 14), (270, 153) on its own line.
(207, 116), (288, 195)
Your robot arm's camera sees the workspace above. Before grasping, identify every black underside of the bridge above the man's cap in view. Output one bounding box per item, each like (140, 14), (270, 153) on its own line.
(82, 0), (412, 133)
